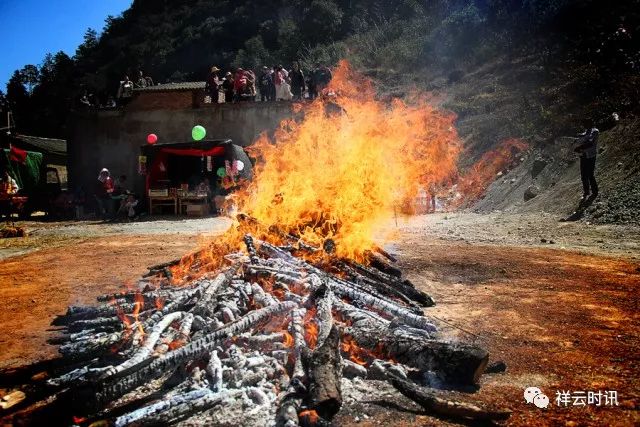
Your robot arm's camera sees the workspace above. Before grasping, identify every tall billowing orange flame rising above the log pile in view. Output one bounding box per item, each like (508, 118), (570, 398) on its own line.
(238, 61), (460, 259)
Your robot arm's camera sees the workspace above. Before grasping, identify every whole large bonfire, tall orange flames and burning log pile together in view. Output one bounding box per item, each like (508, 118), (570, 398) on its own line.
(10, 62), (506, 426)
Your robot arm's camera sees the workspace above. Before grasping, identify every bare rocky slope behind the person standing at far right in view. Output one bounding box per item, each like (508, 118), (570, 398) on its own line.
(474, 118), (640, 224)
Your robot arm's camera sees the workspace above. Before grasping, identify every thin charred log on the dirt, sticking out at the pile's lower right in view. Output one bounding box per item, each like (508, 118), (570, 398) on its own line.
(390, 376), (511, 421)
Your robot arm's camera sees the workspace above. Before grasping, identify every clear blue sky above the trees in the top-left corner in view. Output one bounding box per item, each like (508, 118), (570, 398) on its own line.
(0, 0), (132, 92)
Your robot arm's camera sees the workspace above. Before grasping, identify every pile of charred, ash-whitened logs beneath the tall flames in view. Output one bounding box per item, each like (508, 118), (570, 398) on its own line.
(3, 224), (508, 426)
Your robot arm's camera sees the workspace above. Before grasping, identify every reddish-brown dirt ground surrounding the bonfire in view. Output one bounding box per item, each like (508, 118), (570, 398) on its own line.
(0, 213), (640, 426)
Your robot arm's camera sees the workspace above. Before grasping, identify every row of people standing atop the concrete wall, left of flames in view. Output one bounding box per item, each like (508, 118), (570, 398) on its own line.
(205, 61), (332, 104)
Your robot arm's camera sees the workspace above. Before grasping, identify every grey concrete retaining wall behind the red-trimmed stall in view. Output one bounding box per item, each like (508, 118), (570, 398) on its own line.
(67, 98), (293, 194)
